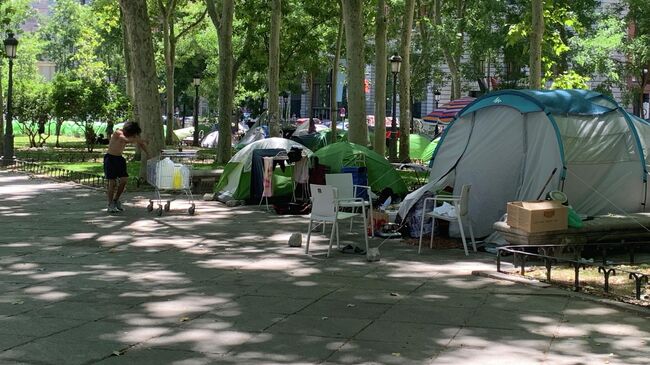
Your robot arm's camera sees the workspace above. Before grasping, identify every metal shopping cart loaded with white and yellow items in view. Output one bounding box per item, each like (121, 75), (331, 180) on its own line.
(147, 150), (197, 216)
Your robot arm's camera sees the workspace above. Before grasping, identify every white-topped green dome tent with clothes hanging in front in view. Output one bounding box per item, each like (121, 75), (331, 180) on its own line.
(215, 138), (312, 202)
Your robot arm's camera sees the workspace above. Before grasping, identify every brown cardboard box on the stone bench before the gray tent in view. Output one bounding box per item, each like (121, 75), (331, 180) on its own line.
(507, 200), (569, 233)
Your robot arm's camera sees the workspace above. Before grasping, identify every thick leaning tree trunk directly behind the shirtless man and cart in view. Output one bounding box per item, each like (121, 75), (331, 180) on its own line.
(120, 0), (164, 178)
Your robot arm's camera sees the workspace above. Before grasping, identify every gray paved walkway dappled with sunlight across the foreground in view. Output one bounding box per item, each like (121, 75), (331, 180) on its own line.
(0, 171), (650, 365)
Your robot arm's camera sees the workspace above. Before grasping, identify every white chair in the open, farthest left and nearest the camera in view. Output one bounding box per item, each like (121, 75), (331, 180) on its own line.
(305, 184), (368, 257)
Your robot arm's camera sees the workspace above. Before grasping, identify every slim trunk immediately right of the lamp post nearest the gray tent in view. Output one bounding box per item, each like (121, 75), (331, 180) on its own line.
(399, 0), (415, 162)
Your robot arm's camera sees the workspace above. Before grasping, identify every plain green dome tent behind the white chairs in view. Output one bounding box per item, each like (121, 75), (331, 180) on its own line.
(314, 142), (407, 195)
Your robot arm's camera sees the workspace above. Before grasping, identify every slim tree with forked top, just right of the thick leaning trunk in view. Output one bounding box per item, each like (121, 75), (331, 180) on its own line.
(157, 0), (207, 144)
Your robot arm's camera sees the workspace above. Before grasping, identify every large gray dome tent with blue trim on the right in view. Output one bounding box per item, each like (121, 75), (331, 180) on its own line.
(400, 90), (650, 236)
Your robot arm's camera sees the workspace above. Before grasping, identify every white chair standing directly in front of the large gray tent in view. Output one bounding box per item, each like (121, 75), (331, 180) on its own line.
(418, 184), (476, 255)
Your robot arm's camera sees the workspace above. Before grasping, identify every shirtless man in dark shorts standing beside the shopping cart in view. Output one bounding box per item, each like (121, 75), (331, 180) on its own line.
(104, 122), (149, 213)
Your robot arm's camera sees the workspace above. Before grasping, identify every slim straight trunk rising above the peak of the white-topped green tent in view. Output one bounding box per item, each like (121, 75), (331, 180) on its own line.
(268, 0), (282, 137)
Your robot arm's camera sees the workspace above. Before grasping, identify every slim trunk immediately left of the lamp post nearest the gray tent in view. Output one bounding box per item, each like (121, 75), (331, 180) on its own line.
(375, 0), (388, 156)
